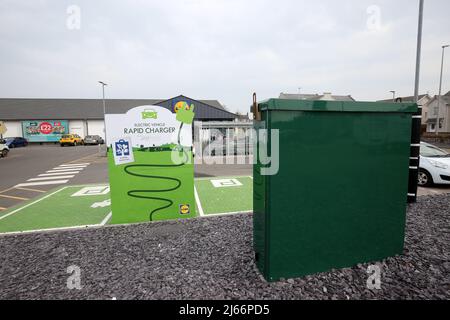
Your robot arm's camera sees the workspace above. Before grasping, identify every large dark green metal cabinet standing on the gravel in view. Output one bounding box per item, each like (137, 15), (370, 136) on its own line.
(253, 99), (418, 281)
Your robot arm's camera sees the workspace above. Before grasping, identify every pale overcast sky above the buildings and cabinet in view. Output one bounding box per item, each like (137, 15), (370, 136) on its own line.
(0, 0), (450, 113)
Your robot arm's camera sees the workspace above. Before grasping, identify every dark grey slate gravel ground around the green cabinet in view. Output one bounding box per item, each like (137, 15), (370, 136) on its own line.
(0, 195), (450, 299)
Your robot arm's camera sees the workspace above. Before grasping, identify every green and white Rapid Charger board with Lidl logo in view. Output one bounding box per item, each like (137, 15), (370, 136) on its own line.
(105, 103), (196, 224)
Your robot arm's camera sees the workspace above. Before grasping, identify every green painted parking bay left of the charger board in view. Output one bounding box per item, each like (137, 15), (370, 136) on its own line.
(0, 185), (111, 233)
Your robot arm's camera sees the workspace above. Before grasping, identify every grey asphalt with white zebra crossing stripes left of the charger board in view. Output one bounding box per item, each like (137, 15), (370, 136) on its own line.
(0, 145), (108, 211)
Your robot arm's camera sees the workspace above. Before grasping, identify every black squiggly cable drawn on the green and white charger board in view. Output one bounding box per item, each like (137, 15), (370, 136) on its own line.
(124, 123), (189, 221)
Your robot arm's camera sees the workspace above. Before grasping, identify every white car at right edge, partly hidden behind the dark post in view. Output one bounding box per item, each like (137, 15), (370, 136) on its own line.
(419, 142), (450, 187)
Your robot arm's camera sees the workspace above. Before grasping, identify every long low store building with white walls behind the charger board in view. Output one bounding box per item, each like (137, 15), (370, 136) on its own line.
(0, 95), (237, 142)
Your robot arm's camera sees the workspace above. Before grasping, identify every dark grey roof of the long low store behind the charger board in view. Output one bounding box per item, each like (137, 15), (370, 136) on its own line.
(0, 95), (236, 120)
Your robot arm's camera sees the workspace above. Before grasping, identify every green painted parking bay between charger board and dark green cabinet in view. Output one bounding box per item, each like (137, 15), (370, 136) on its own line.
(195, 177), (253, 215)
